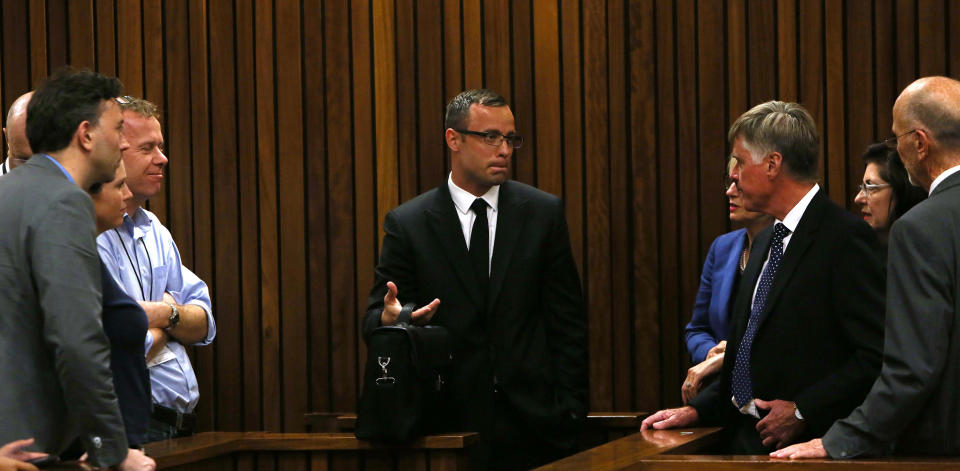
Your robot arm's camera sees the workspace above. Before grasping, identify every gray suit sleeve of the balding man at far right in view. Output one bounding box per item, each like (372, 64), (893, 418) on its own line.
(823, 214), (954, 458)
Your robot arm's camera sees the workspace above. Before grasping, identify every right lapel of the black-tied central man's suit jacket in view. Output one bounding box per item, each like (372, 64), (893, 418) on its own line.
(487, 181), (528, 313)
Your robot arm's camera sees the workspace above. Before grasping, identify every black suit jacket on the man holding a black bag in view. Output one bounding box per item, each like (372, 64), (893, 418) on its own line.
(363, 181), (588, 445)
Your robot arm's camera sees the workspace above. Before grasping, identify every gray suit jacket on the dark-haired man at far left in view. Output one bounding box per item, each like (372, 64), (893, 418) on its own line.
(0, 154), (127, 466)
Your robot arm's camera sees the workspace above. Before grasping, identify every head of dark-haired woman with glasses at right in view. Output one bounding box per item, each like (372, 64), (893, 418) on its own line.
(853, 143), (927, 249)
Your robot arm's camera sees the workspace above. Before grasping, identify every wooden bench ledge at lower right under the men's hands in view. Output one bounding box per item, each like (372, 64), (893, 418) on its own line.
(537, 428), (960, 471)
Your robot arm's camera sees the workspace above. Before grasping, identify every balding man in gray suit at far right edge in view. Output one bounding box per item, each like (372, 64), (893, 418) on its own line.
(771, 77), (960, 458)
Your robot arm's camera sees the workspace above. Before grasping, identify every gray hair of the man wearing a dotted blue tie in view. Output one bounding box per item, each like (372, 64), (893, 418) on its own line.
(727, 100), (820, 181)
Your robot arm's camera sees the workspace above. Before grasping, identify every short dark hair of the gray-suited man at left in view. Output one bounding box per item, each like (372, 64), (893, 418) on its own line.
(27, 67), (123, 154)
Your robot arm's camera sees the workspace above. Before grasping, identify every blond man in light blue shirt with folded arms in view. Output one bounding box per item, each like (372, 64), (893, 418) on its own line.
(97, 96), (217, 442)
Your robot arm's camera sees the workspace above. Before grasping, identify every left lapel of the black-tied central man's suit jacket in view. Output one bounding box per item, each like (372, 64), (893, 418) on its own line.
(424, 184), (484, 306)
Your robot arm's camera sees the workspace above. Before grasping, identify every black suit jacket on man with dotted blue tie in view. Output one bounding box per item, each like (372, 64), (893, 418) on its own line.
(692, 190), (883, 451)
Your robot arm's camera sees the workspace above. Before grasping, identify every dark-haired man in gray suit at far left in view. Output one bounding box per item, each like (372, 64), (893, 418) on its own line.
(0, 70), (154, 469)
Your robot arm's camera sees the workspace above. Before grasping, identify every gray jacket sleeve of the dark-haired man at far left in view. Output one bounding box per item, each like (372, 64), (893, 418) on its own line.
(28, 192), (127, 466)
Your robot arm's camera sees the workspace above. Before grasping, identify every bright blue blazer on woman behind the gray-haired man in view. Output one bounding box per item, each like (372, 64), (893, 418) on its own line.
(686, 229), (747, 363)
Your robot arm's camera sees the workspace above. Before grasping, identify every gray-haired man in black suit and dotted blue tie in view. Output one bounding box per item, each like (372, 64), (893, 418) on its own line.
(642, 101), (883, 454)
